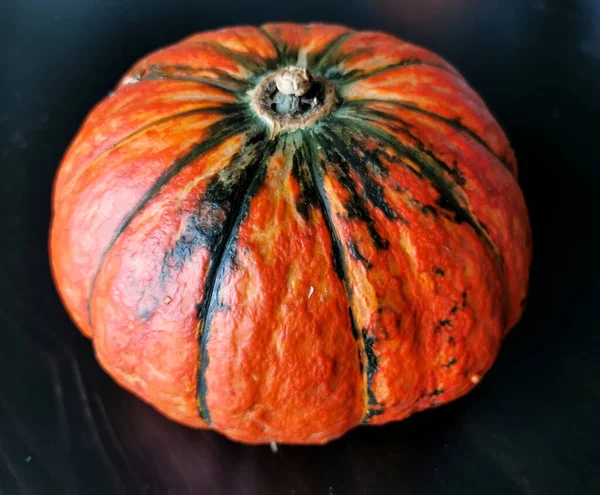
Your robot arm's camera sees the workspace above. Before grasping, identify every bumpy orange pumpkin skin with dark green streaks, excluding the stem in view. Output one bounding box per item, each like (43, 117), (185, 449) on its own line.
(50, 24), (531, 444)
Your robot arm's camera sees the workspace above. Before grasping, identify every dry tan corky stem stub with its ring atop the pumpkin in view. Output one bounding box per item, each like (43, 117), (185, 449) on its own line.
(249, 67), (337, 137)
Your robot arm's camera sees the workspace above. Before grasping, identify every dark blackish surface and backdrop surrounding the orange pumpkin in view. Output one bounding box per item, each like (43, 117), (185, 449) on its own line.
(0, 0), (600, 495)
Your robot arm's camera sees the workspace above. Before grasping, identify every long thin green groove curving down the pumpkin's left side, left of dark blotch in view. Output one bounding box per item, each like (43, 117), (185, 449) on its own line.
(87, 110), (250, 323)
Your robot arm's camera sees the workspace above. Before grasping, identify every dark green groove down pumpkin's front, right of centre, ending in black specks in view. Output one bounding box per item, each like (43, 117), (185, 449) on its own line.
(305, 136), (381, 422)
